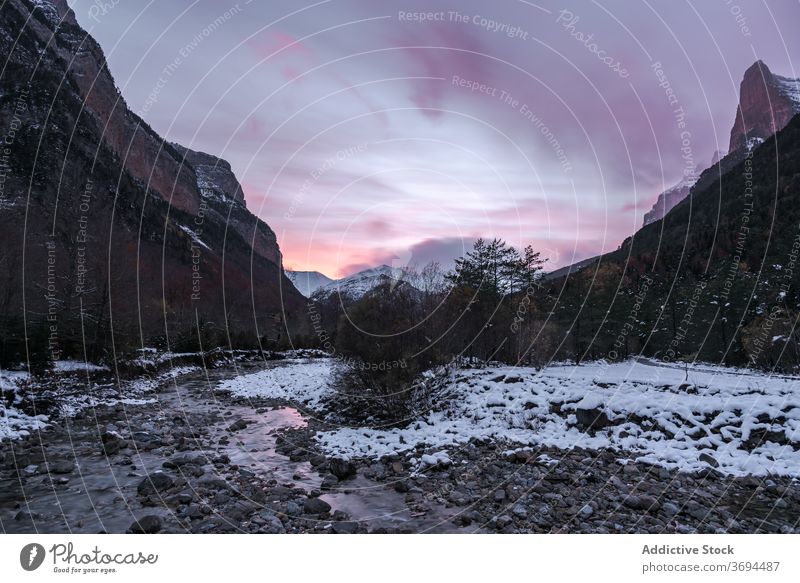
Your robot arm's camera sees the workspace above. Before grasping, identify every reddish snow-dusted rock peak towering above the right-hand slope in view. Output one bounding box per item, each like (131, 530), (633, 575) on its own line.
(730, 61), (800, 151)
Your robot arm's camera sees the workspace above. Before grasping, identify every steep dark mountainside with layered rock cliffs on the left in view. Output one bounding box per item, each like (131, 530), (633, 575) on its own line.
(0, 0), (304, 361)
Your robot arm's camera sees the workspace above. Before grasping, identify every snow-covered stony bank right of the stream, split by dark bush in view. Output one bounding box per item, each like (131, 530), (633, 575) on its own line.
(216, 360), (800, 476)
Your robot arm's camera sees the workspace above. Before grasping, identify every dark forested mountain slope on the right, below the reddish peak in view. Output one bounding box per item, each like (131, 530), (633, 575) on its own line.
(549, 116), (800, 368)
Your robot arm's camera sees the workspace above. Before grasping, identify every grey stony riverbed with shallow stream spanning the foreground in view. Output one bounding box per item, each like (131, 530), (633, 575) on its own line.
(0, 363), (800, 533)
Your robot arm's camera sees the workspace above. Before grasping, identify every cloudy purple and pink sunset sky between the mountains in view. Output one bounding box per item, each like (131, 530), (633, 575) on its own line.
(70, 0), (800, 276)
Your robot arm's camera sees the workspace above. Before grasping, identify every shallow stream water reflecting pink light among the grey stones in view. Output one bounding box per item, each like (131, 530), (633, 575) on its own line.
(0, 363), (457, 533)
